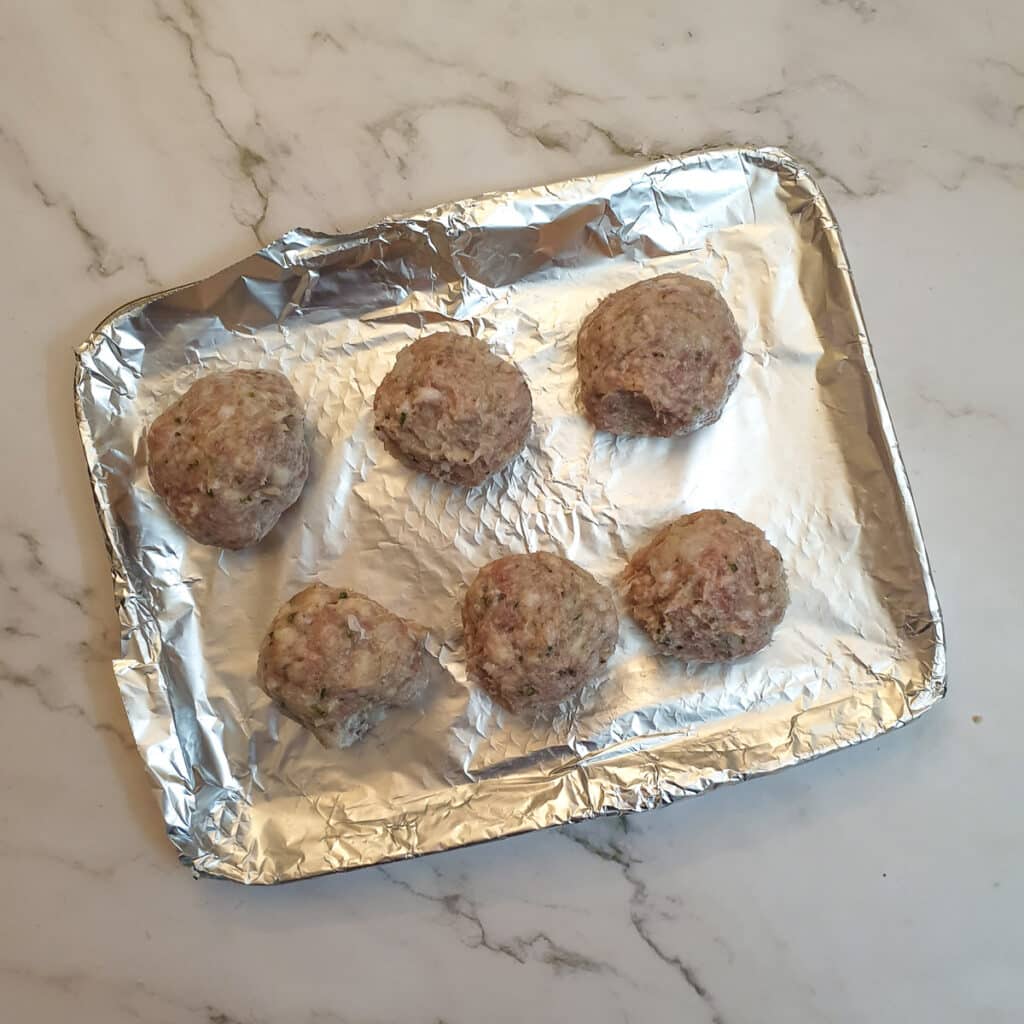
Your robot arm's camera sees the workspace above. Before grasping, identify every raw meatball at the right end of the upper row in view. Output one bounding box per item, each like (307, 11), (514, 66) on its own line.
(577, 273), (742, 437)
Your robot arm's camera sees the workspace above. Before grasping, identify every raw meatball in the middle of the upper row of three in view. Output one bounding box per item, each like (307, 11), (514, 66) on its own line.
(374, 334), (534, 486)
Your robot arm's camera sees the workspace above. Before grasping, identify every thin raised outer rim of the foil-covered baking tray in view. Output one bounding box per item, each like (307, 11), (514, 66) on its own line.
(74, 145), (947, 885)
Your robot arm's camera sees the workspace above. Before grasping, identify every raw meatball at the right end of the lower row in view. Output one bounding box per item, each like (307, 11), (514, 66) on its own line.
(624, 509), (790, 662)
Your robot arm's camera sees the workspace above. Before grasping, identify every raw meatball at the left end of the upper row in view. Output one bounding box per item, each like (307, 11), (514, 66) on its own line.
(147, 370), (309, 549)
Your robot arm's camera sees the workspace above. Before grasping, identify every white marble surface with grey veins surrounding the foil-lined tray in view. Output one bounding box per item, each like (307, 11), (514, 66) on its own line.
(0, 0), (1024, 1024)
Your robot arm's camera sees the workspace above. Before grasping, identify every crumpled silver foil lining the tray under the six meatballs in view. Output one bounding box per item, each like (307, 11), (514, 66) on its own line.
(76, 148), (945, 883)
